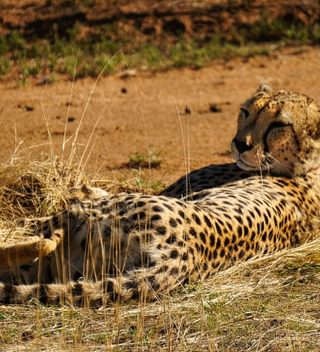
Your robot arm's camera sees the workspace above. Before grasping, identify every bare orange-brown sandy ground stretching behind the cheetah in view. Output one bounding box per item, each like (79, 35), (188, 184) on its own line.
(0, 47), (320, 184)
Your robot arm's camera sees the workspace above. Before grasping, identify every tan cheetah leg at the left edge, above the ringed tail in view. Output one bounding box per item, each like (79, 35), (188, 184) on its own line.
(0, 229), (63, 270)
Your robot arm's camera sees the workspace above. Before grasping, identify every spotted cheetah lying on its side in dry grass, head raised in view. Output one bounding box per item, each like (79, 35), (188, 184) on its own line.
(0, 86), (320, 306)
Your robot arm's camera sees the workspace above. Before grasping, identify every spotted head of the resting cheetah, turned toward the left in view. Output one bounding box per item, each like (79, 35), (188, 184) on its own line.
(231, 85), (320, 177)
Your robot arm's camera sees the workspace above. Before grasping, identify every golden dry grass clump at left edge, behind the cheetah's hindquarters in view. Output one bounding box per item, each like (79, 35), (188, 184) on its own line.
(0, 158), (85, 242)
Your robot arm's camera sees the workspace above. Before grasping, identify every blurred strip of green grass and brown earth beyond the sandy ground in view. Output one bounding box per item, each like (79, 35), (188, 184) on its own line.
(0, 0), (320, 83)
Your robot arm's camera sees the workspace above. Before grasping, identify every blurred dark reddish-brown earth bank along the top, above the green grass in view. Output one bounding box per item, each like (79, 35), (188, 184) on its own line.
(0, 0), (320, 42)
